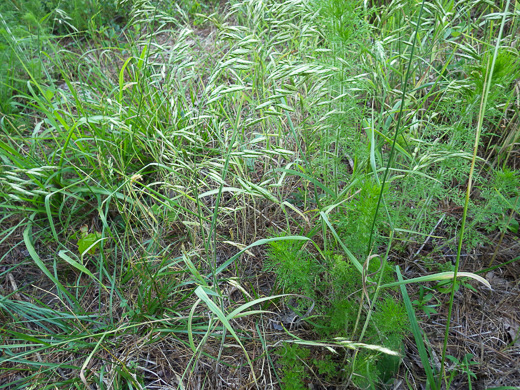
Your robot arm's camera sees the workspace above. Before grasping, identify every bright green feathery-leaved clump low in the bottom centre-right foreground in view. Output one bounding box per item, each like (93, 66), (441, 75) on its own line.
(267, 241), (408, 389)
